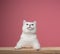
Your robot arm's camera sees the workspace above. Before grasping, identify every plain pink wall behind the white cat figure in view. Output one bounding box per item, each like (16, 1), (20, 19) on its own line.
(0, 0), (60, 47)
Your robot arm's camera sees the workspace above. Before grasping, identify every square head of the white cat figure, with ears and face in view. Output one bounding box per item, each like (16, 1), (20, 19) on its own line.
(22, 20), (36, 33)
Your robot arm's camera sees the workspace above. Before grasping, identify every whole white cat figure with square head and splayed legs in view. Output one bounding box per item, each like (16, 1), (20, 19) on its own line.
(15, 20), (40, 50)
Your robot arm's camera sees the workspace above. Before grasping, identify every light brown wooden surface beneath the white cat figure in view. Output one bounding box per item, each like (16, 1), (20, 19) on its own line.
(0, 47), (60, 54)
